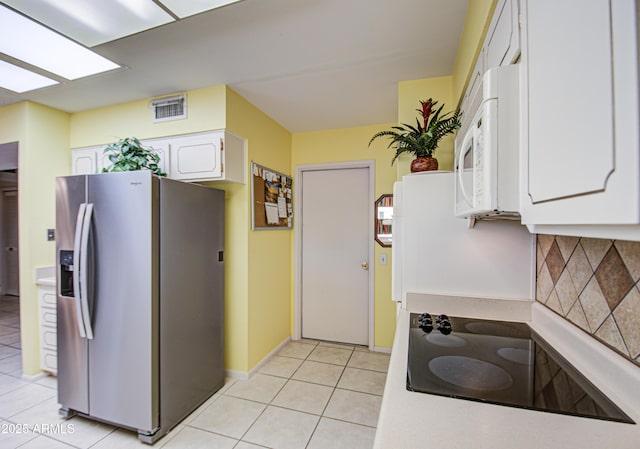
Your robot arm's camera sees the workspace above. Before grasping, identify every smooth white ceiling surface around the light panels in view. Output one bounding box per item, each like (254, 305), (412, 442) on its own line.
(0, 0), (468, 132)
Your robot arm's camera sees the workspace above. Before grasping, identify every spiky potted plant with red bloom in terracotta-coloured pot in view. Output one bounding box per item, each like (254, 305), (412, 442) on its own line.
(369, 98), (461, 173)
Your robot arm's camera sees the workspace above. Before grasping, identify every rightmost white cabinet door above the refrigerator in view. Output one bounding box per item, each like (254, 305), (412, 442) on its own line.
(170, 132), (224, 180)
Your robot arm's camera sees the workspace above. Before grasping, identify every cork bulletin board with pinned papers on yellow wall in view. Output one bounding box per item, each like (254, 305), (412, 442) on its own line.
(251, 162), (293, 231)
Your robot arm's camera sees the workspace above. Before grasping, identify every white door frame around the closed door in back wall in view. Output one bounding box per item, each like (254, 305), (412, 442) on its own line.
(293, 160), (375, 350)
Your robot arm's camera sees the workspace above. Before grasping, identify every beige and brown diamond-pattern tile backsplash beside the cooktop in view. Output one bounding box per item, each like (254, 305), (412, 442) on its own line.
(536, 234), (640, 365)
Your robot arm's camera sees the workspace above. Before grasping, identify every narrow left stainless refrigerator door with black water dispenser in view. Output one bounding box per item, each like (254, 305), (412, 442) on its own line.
(56, 176), (89, 413)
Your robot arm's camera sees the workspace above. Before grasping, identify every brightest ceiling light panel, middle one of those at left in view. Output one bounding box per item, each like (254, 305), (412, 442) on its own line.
(0, 7), (120, 80)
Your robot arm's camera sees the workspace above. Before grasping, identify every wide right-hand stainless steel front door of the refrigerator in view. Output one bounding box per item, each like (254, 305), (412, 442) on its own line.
(87, 171), (159, 433)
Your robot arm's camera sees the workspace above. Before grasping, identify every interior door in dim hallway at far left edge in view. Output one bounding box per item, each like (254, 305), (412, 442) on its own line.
(2, 190), (20, 296)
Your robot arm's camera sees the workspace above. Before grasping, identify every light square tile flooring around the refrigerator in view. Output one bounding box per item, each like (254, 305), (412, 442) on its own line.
(0, 296), (389, 449)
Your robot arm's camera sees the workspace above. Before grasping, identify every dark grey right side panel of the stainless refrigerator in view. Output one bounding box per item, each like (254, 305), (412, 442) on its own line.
(160, 178), (224, 429)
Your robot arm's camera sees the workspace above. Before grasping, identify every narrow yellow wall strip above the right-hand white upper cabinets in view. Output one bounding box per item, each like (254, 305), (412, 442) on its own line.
(452, 0), (498, 106)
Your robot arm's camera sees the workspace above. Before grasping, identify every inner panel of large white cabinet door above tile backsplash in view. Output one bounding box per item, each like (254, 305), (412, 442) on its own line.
(527, 0), (614, 203)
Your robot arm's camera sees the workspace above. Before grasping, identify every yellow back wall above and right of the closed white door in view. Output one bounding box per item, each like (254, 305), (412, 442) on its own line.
(291, 124), (396, 348)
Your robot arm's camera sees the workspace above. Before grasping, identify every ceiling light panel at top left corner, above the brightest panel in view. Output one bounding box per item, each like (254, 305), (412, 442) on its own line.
(2, 0), (174, 47)
